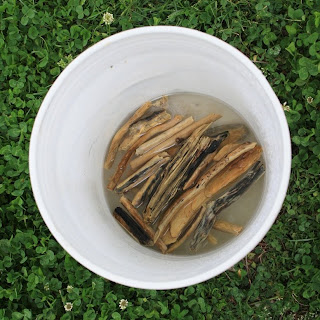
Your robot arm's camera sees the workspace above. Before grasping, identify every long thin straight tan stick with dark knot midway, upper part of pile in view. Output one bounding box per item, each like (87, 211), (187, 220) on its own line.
(130, 114), (221, 169)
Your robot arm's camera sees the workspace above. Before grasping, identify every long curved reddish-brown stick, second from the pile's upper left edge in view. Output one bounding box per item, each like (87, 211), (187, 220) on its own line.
(107, 115), (182, 190)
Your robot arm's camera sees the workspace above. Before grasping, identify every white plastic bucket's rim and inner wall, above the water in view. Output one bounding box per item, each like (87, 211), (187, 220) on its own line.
(30, 27), (291, 289)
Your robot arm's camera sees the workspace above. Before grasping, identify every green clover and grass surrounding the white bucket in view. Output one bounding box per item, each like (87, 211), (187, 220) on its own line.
(0, 0), (320, 320)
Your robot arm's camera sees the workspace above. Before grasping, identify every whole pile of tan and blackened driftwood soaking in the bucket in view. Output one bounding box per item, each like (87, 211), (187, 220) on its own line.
(105, 97), (263, 253)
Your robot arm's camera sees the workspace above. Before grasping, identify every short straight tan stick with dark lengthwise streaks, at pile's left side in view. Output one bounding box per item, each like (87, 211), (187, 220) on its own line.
(114, 152), (170, 193)
